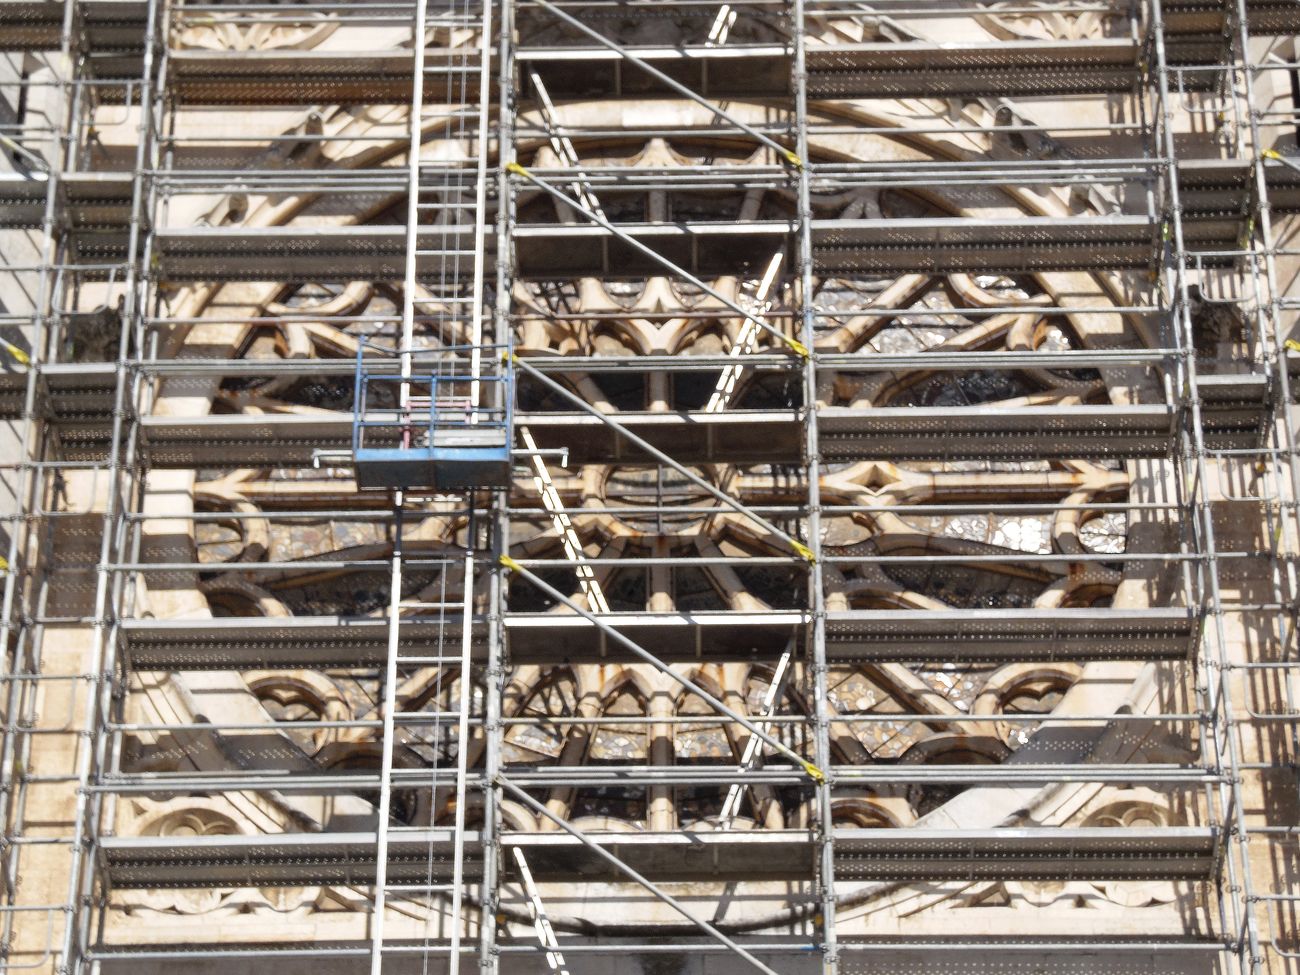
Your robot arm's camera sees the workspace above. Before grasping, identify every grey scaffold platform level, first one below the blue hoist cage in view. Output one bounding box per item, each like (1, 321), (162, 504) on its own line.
(118, 608), (1196, 671)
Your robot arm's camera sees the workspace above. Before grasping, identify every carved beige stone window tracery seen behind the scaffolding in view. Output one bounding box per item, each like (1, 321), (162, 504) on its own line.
(116, 5), (1201, 935)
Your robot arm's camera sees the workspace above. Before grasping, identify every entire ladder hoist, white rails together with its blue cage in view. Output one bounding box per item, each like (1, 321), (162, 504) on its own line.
(371, 0), (501, 975)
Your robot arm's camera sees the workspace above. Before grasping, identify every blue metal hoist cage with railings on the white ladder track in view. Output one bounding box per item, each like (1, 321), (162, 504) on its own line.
(352, 345), (515, 491)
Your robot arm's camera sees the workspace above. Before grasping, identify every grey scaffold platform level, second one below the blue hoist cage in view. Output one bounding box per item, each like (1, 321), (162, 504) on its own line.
(100, 827), (1218, 889)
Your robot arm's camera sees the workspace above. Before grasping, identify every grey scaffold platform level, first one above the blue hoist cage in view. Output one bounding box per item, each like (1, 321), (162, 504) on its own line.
(142, 216), (1239, 282)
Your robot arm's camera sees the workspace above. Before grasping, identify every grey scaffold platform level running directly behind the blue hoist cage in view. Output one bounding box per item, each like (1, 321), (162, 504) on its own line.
(129, 406), (1174, 468)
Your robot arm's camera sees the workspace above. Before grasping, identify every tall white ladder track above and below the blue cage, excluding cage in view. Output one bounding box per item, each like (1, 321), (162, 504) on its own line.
(371, 0), (493, 975)
